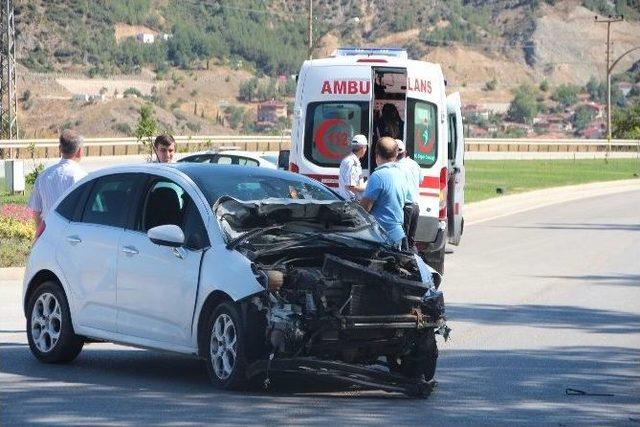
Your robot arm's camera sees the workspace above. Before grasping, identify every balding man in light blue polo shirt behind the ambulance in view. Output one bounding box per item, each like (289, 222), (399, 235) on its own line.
(360, 137), (408, 248)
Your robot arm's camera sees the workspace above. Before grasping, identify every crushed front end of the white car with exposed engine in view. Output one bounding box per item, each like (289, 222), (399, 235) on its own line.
(216, 199), (449, 395)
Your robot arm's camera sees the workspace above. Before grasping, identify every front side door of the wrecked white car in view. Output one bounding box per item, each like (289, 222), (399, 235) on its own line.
(117, 176), (209, 345)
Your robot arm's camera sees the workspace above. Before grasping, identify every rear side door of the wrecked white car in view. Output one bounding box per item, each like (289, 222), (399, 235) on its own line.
(56, 173), (138, 335)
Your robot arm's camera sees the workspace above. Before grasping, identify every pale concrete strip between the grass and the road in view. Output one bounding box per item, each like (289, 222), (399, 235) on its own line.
(464, 178), (640, 226)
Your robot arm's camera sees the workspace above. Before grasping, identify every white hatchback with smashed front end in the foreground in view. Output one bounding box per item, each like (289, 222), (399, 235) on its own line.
(23, 163), (448, 394)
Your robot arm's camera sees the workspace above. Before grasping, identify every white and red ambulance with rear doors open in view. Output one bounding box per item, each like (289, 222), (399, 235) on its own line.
(288, 48), (464, 273)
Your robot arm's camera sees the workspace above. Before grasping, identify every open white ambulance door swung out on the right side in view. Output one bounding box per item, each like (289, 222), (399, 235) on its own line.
(447, 92), (465, 245)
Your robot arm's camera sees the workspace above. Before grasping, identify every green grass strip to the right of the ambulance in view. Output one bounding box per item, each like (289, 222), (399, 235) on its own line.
(464, 159), (640, 203)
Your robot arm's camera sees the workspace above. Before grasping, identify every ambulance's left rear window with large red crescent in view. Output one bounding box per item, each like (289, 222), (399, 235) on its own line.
(304, 102), (369, 168)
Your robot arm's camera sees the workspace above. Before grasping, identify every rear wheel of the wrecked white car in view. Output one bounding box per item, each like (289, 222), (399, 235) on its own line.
(27, 281), (84, 363)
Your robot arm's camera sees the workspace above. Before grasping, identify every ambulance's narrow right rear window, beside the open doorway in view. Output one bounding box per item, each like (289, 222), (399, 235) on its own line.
(406, 98), (438, 167)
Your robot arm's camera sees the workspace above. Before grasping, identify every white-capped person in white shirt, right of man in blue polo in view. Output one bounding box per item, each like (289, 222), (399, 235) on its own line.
(396, 139), (420, 254)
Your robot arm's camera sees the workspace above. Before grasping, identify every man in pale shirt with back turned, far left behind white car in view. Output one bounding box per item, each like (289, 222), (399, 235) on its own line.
(29, 129), (87, 230)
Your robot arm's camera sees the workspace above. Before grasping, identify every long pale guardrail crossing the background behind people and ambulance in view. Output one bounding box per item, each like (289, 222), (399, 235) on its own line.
(0, 135), (640, 157)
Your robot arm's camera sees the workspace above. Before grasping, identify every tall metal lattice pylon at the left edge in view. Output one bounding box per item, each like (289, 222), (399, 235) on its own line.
(0, 0), (18, 158)
